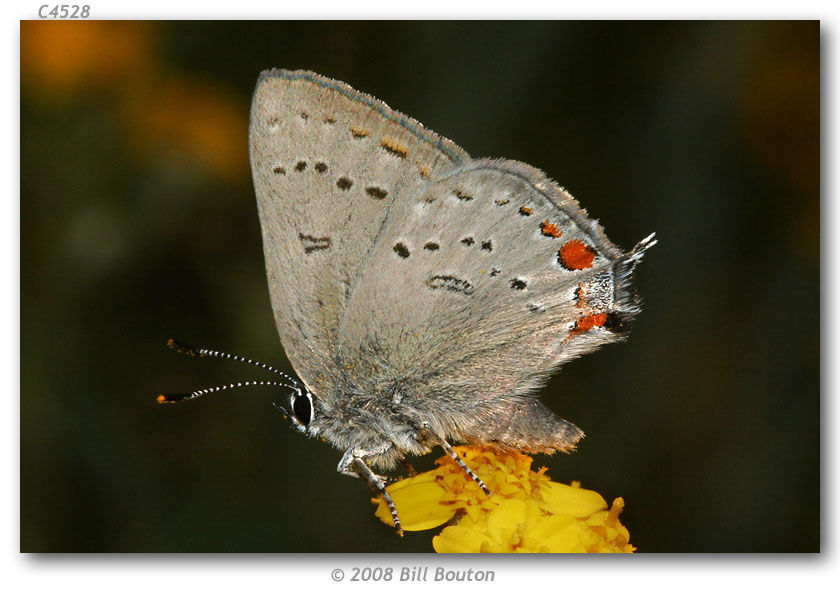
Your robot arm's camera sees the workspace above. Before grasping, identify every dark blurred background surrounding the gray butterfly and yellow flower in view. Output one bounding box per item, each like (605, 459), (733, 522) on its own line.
(20, 21), (820, 552)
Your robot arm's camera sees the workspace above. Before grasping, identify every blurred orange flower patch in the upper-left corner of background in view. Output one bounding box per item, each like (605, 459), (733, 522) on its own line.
(21, 21), (248, 180)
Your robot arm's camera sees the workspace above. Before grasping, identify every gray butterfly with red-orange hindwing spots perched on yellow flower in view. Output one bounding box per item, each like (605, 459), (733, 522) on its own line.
(159, 69), (655, 531)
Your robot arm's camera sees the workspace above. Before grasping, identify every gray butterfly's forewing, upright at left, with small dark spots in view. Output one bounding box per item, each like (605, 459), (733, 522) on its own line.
(250, 70), (469, 401)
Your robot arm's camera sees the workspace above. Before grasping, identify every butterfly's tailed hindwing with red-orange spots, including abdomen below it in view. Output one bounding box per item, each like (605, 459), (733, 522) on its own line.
(340, 159), (652, 452)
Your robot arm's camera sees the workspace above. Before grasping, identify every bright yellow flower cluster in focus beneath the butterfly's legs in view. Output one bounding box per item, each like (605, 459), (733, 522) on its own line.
(373, 446), (635, 552)
